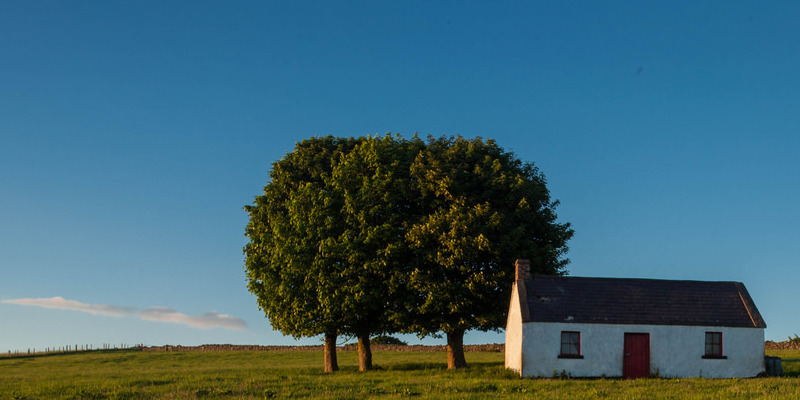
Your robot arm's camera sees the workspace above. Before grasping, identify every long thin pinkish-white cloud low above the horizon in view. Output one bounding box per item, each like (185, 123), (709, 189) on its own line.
(0, 297), (247, 330)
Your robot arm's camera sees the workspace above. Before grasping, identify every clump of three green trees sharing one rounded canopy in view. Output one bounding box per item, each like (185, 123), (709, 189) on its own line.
(244, 135), (572, 371)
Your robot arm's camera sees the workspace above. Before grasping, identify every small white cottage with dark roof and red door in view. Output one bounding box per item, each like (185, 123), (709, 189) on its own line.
(505, 260), (766, 378)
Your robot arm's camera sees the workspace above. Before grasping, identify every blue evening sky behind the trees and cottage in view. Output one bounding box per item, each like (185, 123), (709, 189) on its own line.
(0, 1), (800, 351)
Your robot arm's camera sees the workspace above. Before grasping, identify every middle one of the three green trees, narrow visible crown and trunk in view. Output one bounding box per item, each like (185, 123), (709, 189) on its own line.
(330, 135), (423, 370)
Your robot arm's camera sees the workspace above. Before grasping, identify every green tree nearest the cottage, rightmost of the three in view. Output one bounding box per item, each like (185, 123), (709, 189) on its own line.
(404, 136), (573, 368)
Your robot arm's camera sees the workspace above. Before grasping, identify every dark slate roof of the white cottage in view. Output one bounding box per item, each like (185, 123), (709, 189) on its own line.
(518, 275), (767, 328)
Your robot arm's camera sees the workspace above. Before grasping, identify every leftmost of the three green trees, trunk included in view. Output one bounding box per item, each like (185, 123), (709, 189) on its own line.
(244, 136), (359, 372)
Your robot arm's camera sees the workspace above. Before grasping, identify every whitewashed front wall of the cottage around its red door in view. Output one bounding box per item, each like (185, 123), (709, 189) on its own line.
(506, 322), (764, 378)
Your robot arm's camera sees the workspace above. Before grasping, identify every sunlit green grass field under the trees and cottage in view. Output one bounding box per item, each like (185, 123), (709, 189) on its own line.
(0, 350), (800, 399)
